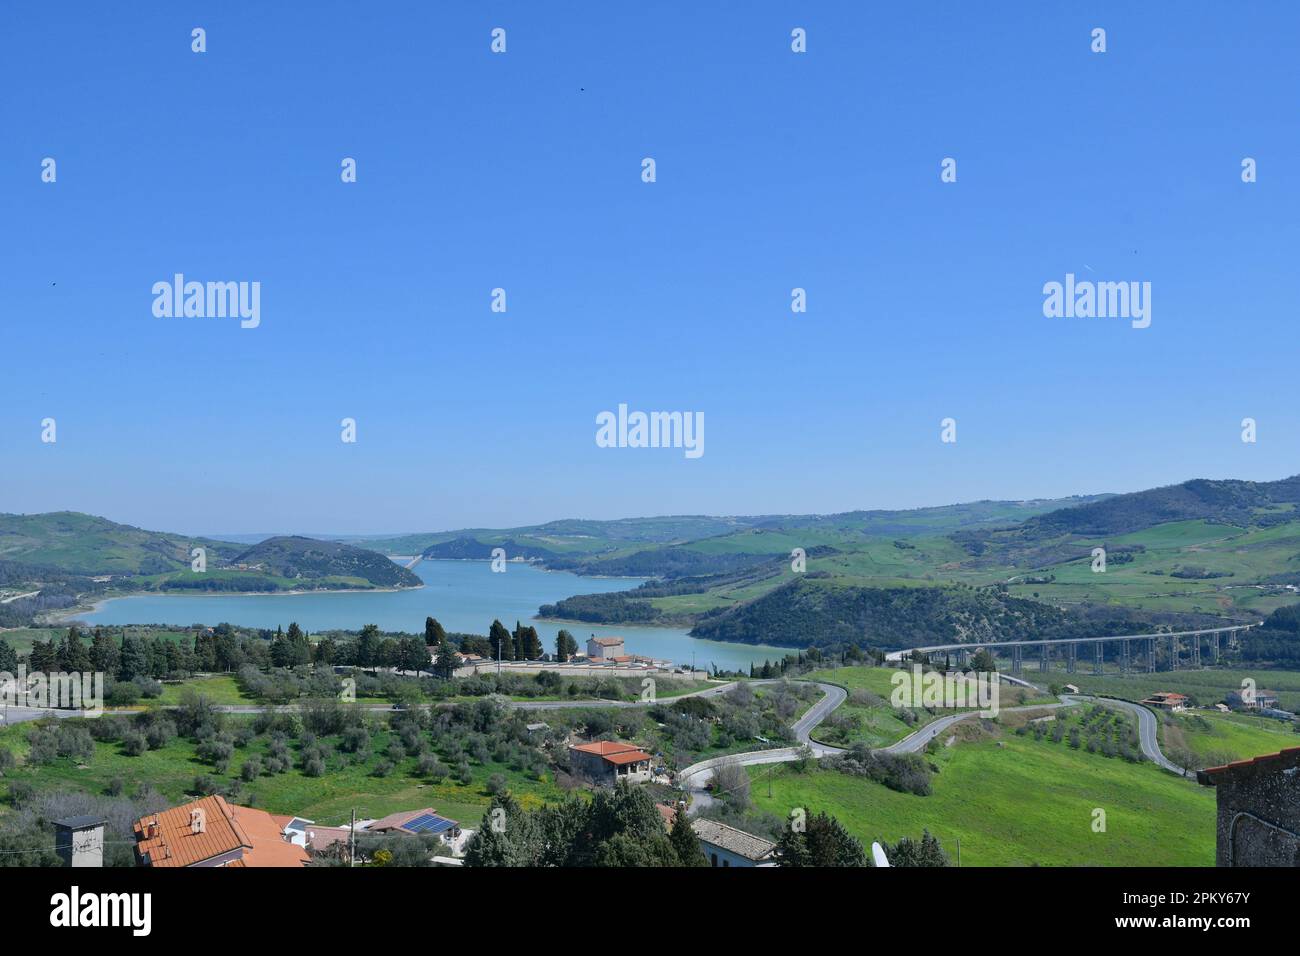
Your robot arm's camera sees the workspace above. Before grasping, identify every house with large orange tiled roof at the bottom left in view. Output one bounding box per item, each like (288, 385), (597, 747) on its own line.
(133, 796), (308, 866)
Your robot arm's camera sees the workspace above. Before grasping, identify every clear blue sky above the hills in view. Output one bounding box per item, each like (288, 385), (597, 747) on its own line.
(0, 3), (1300, 532)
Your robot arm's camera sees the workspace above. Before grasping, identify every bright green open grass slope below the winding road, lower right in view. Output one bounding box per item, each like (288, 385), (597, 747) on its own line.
(750, 735), (1216, 866)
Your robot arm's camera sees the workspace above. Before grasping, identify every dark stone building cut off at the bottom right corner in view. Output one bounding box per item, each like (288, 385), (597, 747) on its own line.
(1196, 747), (1300, 866)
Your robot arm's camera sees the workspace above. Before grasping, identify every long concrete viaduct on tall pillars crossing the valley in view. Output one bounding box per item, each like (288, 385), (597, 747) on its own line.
(887, 624), (1258, 674)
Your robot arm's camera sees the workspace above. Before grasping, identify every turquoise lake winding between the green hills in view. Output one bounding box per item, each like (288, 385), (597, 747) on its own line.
(77, 561), (790, 670)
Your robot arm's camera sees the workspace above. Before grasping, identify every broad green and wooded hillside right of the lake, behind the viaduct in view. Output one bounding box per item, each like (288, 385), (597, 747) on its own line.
(530, 477), (1300, 645)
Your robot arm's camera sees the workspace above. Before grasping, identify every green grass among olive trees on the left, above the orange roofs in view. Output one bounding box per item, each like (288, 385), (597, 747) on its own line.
(0, 718), (563, 826)
